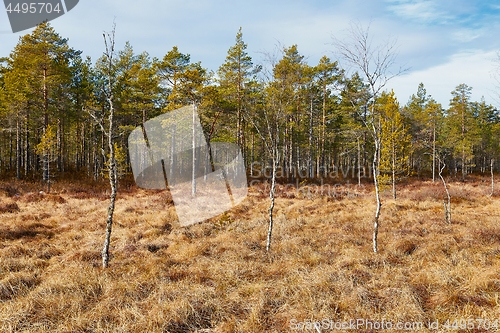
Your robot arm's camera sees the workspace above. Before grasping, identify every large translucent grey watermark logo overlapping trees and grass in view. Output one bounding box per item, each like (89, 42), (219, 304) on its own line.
(128, 106), (248, 226)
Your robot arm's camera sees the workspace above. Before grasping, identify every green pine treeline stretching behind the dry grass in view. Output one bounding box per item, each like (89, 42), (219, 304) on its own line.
(0, 23), (500, 182)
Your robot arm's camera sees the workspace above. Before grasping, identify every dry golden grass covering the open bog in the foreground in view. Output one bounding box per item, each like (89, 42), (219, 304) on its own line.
(0, 178), (500, 333)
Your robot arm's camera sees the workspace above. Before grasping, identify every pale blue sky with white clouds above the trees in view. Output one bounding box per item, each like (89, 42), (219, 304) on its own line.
(0, 0), (500, 108)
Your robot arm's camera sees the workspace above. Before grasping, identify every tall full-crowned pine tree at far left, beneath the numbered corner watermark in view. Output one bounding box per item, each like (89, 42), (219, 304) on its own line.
(1, 22), (81, 177)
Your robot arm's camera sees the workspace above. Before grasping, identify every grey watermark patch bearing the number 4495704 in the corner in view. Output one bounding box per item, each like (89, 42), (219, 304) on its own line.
(3, 0), (79, 33)
